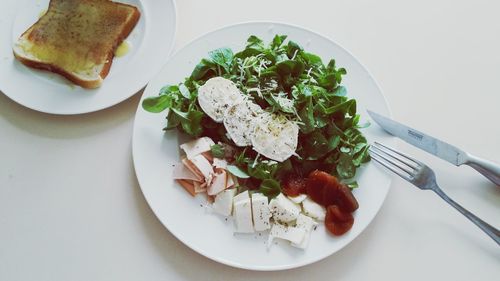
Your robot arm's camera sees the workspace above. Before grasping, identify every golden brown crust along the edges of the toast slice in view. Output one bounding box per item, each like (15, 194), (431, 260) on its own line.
(14, 0), (140, 88)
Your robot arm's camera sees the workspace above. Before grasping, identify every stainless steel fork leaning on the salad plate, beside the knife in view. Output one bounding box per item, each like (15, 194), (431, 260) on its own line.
(370, 142), (500, 246)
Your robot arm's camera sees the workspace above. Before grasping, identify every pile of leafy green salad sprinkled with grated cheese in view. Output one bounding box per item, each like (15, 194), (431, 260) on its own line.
(142, 35), (370, 196)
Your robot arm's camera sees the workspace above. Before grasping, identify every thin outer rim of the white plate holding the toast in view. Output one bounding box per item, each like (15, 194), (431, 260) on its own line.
(0, 0), (179, 116)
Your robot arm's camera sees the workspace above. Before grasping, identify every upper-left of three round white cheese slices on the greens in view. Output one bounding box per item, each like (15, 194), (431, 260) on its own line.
(198, 77), (244, 123)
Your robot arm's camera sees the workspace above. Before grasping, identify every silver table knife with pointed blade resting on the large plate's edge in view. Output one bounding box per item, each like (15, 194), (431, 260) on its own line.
(367, 110), (500, 185)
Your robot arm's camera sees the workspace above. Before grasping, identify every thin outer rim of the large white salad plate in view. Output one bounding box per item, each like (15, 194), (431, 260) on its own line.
(132, 20), (395, 272)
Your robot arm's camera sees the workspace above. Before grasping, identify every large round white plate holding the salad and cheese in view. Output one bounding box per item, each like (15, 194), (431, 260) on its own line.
(133, 22), (393, 270)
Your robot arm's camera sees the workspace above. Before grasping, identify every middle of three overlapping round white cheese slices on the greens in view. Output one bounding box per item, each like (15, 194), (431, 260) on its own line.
(224, 100), (264, 146)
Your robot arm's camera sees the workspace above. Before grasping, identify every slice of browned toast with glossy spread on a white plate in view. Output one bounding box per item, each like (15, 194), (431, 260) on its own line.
(13, 0), (140, 88)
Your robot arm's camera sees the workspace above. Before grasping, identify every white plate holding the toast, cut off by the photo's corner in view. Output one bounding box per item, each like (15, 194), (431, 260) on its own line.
(0, 0), (176, 114)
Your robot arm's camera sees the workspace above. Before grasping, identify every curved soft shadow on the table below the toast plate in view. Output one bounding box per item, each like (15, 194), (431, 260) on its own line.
(0, 90), (142, 139)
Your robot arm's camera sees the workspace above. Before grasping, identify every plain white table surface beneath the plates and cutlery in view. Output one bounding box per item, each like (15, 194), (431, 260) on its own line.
(0, 0), (500, 281)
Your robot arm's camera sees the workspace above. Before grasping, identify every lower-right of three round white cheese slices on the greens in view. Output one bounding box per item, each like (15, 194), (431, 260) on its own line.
(251, 114), (299, 162)
